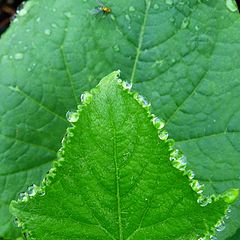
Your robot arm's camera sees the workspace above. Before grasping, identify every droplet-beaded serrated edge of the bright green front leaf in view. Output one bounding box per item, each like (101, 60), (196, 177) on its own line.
(10, 70), (239, 240)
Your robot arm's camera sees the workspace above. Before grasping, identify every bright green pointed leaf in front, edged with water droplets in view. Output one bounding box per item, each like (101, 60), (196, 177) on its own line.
(11, 72), (231, 240)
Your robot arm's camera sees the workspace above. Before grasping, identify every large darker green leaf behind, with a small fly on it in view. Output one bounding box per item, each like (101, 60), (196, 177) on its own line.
(0, 0), (240, 239)
